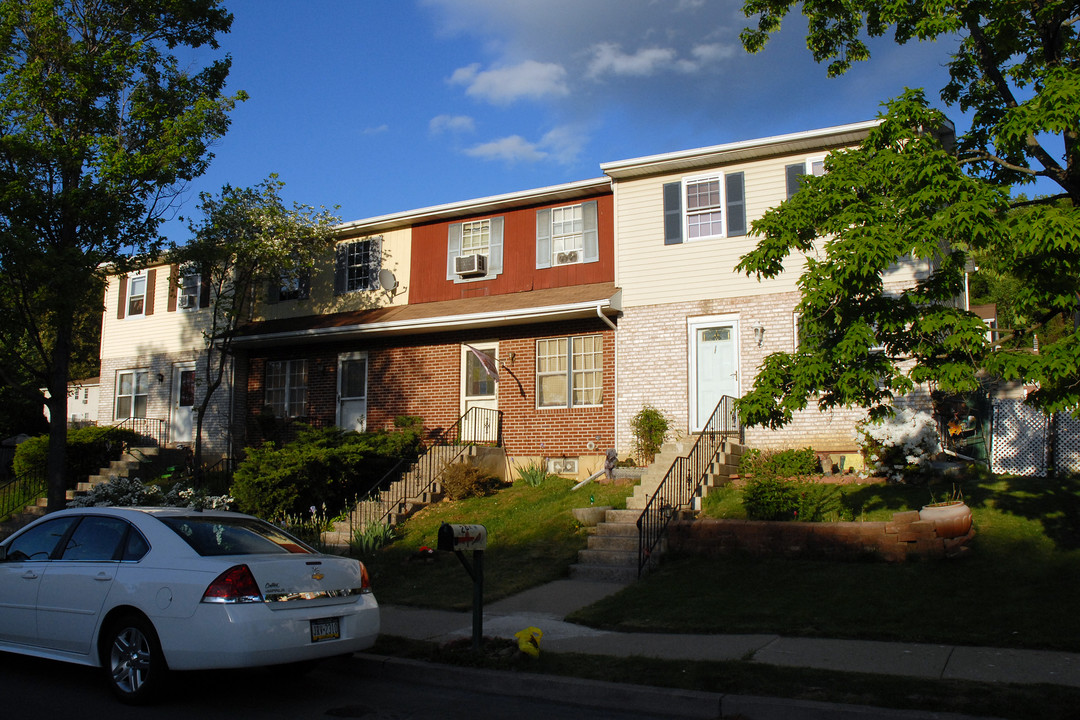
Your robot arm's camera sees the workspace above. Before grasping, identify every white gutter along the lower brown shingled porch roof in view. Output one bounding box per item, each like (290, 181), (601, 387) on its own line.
(233, 290), (622, 345)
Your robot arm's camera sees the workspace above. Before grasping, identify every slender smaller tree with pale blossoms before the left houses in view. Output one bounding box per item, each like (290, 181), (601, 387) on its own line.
(170, 176), (340, 468)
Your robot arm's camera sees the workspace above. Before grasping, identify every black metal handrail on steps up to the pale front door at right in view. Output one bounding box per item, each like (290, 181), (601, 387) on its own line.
(637, 395), (742, 575)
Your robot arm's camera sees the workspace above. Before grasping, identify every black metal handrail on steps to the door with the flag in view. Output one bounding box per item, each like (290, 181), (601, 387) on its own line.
(349, 408), (502, 533)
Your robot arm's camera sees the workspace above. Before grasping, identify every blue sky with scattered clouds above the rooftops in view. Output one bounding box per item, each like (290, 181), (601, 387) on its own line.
(165, 0), (964, 242)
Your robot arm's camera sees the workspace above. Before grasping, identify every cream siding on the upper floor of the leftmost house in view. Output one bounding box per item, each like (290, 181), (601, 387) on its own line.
(102, 264), (211, 359)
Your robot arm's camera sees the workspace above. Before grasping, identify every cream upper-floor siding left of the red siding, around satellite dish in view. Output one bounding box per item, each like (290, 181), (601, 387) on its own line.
(257, 228), (413, 320)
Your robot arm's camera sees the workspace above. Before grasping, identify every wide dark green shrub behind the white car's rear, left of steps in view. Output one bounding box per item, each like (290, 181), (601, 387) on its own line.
(232, 425), (420, 518)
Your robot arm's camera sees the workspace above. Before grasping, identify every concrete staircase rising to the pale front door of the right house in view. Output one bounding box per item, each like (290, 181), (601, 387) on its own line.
(570, 437), (743, 582)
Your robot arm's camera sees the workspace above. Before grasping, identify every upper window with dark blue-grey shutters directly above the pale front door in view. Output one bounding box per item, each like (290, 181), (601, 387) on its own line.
(663, 173), (746, 245)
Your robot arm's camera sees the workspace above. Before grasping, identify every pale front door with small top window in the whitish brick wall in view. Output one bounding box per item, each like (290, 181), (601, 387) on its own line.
(689, 321), (739, 432)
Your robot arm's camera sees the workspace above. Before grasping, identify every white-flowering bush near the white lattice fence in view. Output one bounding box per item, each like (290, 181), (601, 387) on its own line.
(858, 408), (942, 483)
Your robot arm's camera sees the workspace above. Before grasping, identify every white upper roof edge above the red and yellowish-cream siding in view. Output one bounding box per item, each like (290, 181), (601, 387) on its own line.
(334, 177), (611, 235)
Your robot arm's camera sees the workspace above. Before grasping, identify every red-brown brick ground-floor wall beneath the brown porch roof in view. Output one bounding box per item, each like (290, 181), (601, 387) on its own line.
(238, 320), (615, 457)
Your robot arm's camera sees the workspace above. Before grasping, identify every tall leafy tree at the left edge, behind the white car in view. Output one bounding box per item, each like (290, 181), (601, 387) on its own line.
(0, 0), (241, 510)
